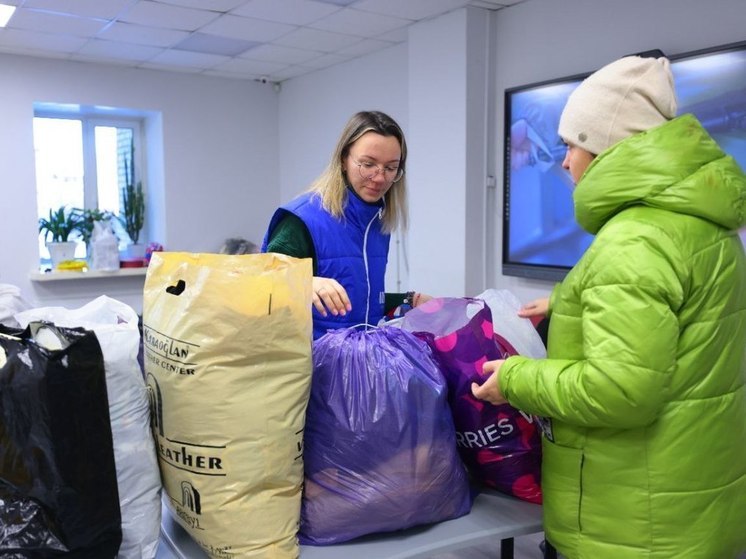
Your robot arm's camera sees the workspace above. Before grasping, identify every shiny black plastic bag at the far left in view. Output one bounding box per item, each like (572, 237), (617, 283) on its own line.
(0, 323), (122, 559)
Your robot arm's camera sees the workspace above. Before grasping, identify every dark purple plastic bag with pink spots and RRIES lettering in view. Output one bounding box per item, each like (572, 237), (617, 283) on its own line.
(401, 298), (541, 503)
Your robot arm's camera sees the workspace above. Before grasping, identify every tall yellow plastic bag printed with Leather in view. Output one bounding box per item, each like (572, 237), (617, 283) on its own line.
(143, 252), (312, 559)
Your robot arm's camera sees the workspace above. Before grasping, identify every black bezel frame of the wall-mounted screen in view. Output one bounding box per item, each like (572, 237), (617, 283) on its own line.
(501, 41), (746, 282)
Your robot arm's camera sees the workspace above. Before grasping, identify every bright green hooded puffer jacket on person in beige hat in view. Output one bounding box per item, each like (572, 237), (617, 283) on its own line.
(499, 115), (746, 559)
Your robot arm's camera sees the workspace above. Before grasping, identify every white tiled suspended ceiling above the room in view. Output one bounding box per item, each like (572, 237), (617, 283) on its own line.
(0, 0), (525, 82)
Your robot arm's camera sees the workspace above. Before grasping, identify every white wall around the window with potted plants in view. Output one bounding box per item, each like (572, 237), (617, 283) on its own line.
(0, 55), (280, 311)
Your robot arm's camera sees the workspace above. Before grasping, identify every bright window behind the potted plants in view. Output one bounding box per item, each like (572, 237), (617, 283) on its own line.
(34, 104), (144, 265)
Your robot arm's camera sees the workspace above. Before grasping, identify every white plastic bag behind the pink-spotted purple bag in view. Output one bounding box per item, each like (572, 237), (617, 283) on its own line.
(476, 289), (547, 359)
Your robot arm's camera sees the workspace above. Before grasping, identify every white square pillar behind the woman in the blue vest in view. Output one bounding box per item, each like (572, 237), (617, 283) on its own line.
(409, 8), (491, 297)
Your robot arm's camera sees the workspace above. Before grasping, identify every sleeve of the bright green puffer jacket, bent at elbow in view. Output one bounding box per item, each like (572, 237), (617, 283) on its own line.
(499, 218), (683, 428)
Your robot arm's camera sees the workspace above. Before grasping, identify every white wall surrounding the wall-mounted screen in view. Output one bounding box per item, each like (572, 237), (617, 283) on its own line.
(488, 0), (746, 300)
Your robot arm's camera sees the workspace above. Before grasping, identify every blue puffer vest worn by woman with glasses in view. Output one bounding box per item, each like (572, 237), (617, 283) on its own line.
(264, 192), (391, 339)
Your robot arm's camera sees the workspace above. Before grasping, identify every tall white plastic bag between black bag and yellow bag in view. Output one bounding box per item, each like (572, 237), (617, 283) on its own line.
(15, 296), (161, 559)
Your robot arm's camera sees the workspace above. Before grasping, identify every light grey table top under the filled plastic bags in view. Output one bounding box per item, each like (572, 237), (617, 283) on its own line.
(159, 490), (543, 559)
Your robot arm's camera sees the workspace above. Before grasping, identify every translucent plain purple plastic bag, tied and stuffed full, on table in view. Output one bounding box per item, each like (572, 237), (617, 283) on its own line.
(299, 327), (471, 545)
